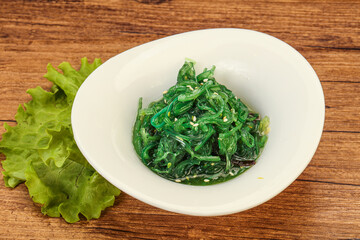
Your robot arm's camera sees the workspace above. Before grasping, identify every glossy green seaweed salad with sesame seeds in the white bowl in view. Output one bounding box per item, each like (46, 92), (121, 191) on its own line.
(133, 61), (270, 185)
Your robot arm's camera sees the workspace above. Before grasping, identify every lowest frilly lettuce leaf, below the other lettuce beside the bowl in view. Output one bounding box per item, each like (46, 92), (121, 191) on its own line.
(25, 159), (119, 223)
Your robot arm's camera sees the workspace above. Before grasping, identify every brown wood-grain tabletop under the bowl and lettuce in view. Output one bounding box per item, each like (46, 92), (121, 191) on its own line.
(0, 0), (360, 239)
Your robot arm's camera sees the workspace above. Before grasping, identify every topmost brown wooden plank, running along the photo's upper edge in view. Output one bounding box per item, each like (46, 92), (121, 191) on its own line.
(0, 0), (360, 48)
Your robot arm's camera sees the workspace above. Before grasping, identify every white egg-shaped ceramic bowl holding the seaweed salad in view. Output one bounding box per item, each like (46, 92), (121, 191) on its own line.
(72, 29), (325, 216)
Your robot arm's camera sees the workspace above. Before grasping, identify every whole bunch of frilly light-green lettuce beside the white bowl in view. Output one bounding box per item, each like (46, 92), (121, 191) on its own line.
(0, 58), (120, 223)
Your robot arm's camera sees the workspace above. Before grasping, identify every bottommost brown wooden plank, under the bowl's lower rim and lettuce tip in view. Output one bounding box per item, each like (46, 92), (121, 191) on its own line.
(0, 177), (360, 239)
